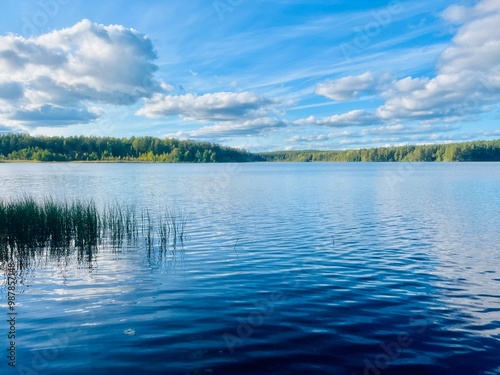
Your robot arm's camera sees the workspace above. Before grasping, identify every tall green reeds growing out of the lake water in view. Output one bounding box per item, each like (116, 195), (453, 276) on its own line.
(0, 197), (185, 270)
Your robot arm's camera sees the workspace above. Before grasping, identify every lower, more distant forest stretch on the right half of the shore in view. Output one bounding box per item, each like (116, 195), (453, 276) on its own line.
(259, 140), (500, 162)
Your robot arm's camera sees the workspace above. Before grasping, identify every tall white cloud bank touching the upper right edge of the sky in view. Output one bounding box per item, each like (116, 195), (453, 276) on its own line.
(377, 0), (500, 121)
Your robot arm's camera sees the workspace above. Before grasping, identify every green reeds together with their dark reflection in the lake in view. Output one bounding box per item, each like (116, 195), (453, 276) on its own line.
(0, 197), (186, 284)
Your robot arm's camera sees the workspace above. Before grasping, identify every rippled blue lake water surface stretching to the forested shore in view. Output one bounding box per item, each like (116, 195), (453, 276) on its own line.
(0, 163), (500, 375)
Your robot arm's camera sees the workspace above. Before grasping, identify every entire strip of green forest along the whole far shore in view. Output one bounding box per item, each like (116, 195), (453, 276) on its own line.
(0, 134), (500, 163)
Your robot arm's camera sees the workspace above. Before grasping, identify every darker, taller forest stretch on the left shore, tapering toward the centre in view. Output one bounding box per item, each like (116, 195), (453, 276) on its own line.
(0, 134), (263, 163)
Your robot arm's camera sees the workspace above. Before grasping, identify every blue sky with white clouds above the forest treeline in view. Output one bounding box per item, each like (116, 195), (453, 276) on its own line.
(0, 0), (500, 151)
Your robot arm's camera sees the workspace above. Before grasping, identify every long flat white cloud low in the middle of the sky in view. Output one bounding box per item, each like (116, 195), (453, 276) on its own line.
(137, 92), (276, 121)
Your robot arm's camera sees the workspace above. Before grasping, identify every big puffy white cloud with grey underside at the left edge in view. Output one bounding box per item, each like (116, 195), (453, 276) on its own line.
(0, 20), (160, 128)
